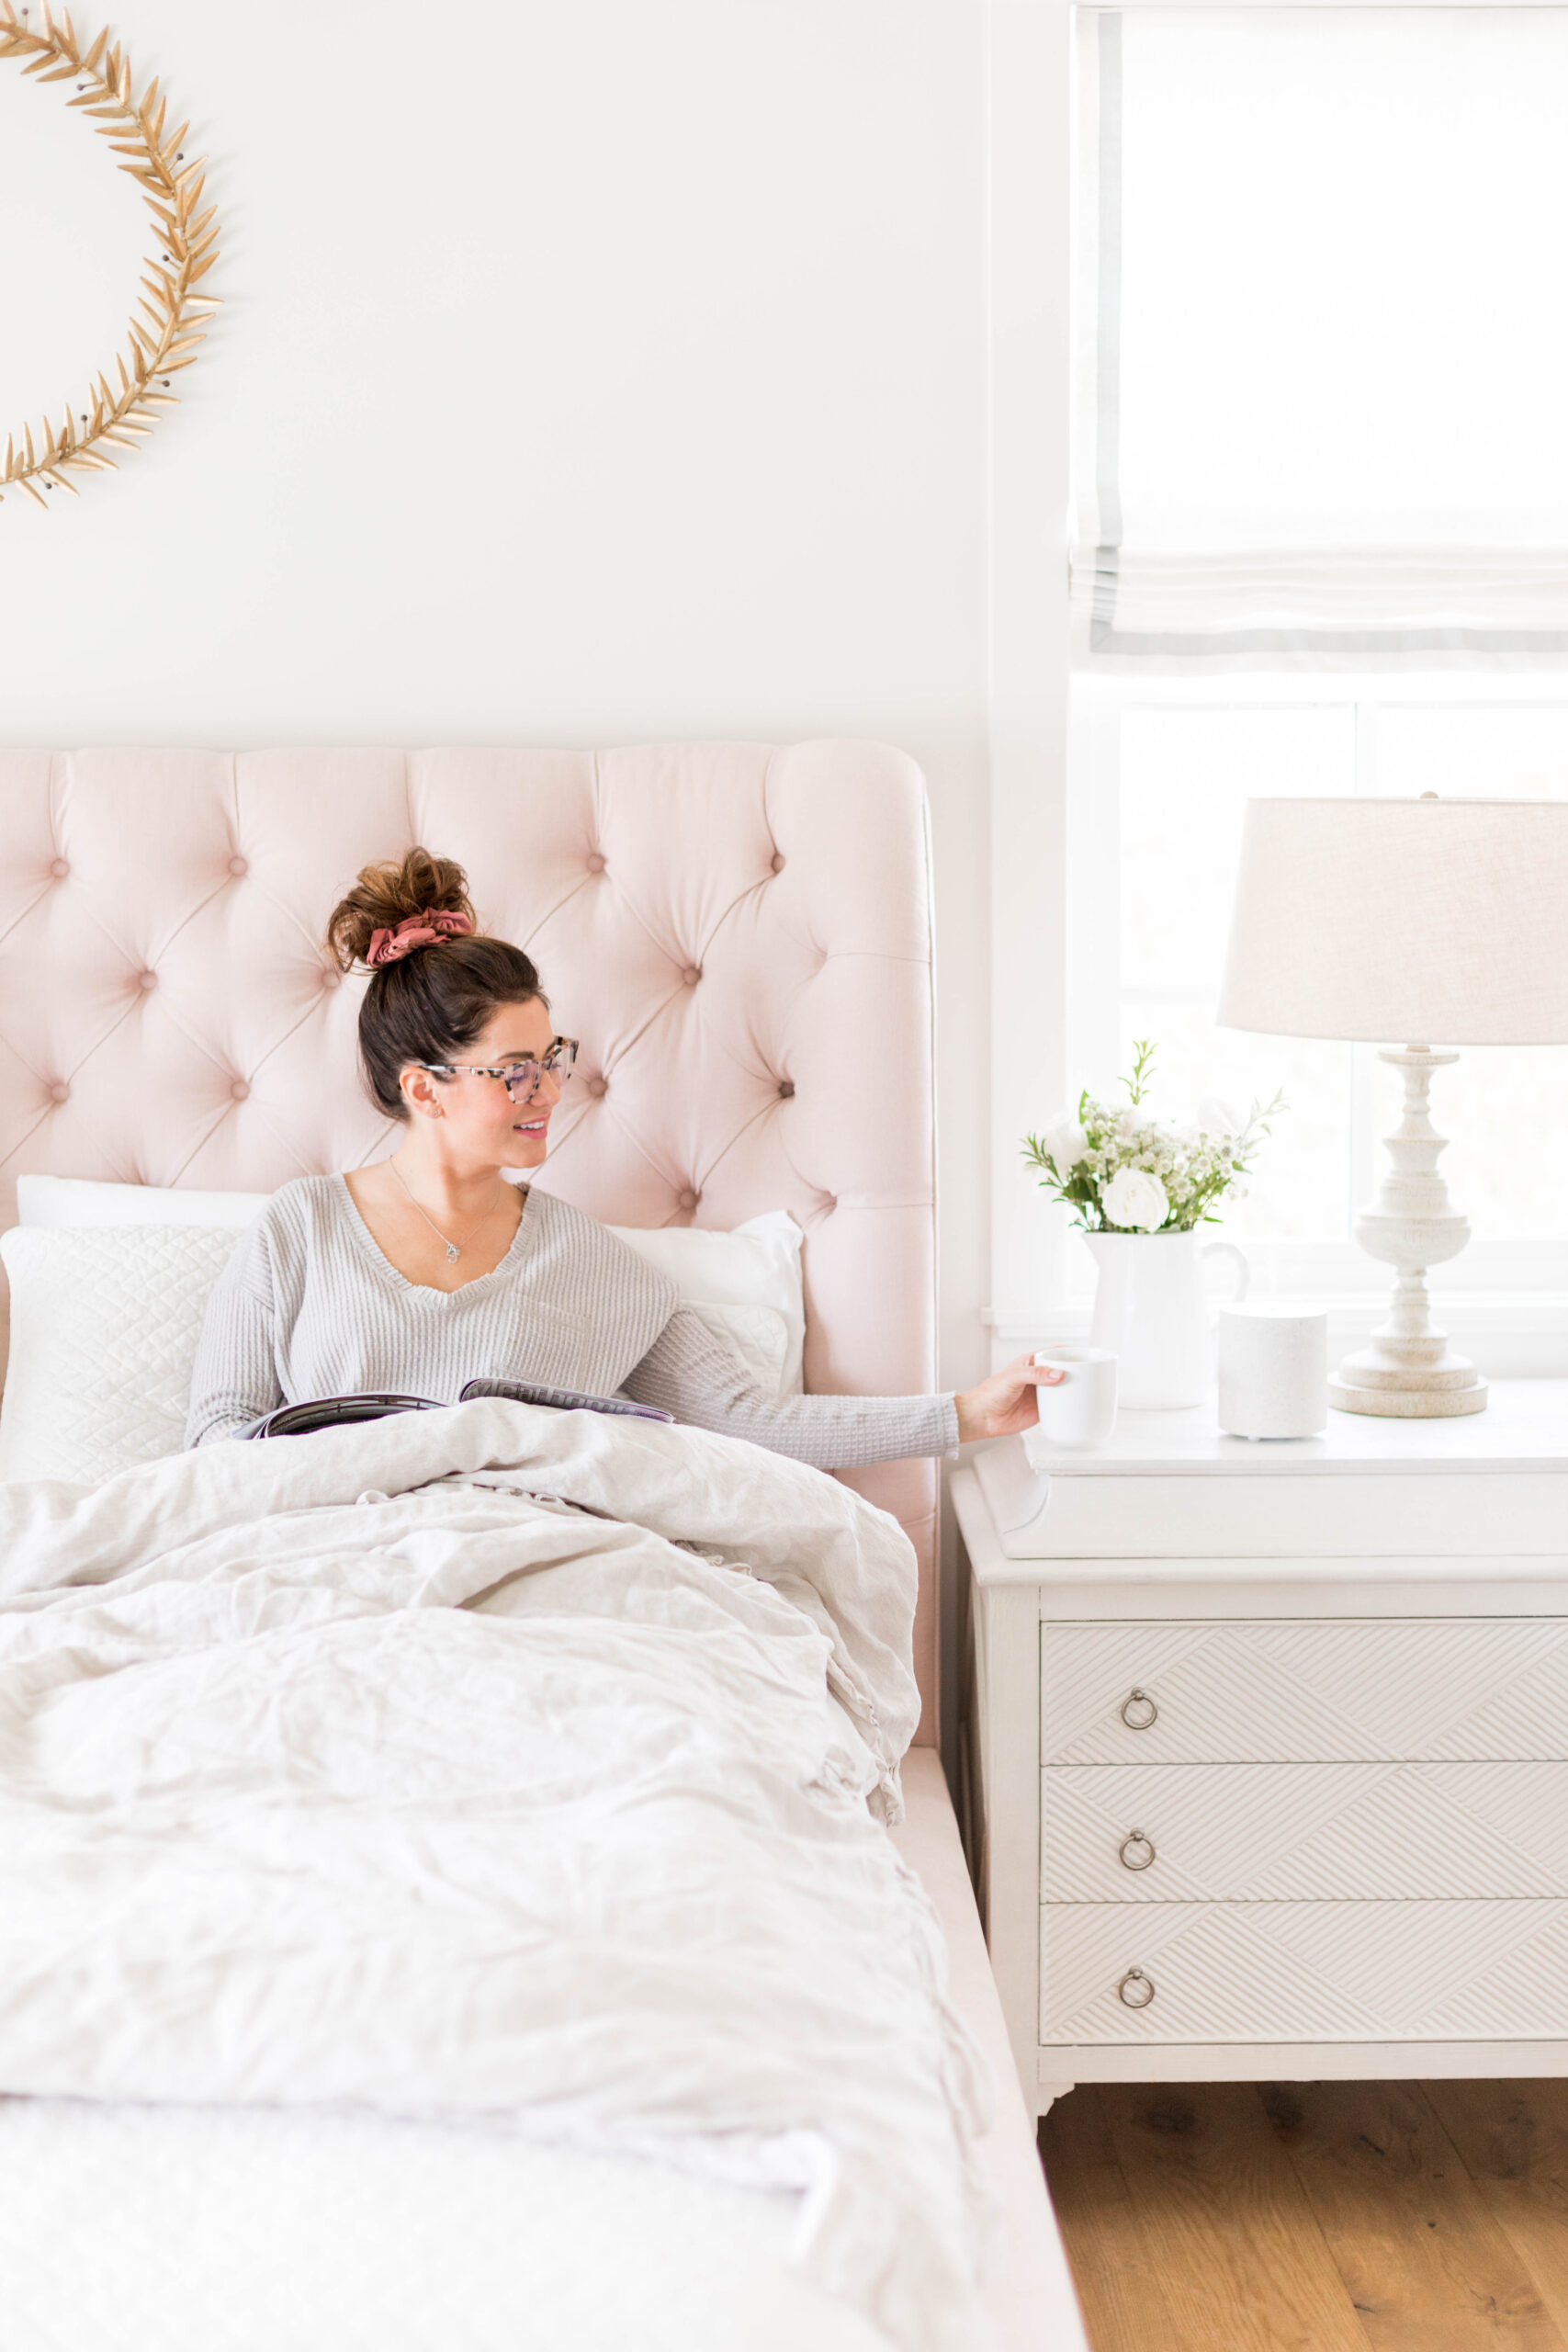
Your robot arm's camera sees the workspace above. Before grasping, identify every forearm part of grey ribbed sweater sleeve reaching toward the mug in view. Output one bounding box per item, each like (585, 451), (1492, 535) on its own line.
(623, 1307), (959, 1470)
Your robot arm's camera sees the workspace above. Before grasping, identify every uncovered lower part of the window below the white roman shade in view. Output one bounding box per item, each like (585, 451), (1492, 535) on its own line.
(1069, 675), (1568, 1291)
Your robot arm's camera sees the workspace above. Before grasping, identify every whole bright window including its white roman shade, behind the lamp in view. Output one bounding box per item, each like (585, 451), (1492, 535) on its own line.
(1067, 7), (1568, 1326)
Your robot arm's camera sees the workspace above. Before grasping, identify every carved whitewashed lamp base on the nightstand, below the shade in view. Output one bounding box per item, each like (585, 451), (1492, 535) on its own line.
(1328, 1045), (1485, 1420)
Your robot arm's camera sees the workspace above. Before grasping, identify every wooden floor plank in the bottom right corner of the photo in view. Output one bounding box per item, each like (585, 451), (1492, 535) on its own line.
(1422, 2082), (1568, 2335)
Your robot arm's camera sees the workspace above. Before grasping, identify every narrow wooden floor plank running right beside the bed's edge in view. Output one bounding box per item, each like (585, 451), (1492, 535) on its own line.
(1039, 2082), (1173, 2352)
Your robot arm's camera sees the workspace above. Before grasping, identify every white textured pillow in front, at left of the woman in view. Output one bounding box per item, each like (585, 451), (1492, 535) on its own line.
(0, 1223), (235, 1487)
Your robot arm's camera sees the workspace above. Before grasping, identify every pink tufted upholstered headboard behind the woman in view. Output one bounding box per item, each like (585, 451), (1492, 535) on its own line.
(0, 743), (936, 1740)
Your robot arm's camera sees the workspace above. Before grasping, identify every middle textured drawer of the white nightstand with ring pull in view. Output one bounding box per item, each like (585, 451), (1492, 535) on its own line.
(1042, 1764), (1568, 1903)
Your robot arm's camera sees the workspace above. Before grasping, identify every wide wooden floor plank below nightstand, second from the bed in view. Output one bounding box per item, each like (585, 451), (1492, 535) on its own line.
(1090, 2084), (1368, 2352)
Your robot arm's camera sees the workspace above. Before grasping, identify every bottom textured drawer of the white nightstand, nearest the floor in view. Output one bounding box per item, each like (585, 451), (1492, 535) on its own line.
(1039, 1900), (1568, 2044)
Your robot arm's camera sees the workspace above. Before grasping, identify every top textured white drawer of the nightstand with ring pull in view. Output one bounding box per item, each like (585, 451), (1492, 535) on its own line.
(1042, 1618), (1568, 1764)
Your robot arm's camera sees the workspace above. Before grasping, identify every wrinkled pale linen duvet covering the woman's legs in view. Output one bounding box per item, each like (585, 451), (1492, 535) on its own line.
(0, 1399), (987, 2352)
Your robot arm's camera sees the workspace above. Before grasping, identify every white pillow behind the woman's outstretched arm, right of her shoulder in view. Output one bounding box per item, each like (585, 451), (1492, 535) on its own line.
(609, 1209), (807, 1397)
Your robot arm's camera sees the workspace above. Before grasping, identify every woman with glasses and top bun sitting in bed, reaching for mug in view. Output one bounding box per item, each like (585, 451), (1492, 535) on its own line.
(186, 849), (1060, 1470)
